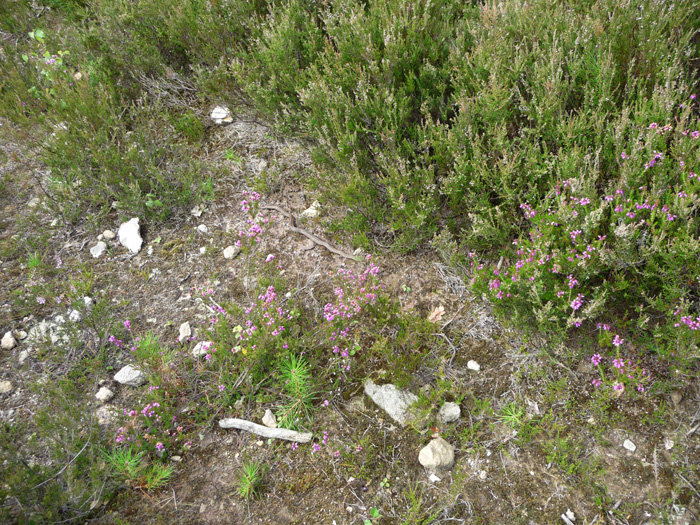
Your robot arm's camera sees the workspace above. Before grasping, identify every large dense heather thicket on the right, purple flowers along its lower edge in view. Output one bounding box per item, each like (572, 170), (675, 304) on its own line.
(234, 0), (700, 354)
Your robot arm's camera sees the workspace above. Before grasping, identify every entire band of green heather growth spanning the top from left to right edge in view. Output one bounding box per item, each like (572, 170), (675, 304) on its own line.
(0, 0), (700, 356)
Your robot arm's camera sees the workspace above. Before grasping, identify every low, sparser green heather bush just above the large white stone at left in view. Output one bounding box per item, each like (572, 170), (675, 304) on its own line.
(2, 30), (213, 220)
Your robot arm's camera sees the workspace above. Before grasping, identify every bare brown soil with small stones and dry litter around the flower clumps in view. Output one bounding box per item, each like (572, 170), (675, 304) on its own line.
(0, 115), (700, 524)
